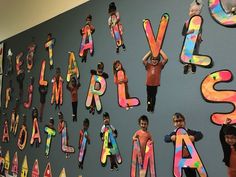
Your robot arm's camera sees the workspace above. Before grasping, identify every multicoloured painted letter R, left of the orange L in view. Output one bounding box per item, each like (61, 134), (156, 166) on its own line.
(86, 74), (107, 112)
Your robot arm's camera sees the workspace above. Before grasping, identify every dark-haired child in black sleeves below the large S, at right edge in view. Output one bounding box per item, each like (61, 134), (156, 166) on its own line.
(220, 118), (236, 177)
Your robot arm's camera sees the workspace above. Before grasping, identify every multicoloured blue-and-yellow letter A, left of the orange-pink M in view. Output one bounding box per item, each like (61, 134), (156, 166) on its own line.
(101, 127), (122, 166)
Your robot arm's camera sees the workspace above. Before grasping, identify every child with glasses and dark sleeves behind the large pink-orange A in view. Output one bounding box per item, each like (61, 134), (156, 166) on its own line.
(164, 113), (203, 177)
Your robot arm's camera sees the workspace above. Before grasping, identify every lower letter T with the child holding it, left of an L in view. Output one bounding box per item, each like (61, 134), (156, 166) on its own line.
(44, 117), (56, 157)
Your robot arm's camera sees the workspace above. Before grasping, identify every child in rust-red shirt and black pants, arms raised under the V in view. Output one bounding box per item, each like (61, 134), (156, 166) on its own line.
(143, 50), (168, 112)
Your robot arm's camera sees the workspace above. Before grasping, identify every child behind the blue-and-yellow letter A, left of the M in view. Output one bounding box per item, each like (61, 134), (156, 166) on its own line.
(100, 112), (118, 170)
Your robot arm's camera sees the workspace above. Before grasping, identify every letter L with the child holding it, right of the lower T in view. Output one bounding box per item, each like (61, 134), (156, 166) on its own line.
(58, 112), (75, 158)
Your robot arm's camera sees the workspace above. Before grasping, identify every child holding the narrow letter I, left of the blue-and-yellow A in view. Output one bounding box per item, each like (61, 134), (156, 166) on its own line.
(79, 118), (90, 169)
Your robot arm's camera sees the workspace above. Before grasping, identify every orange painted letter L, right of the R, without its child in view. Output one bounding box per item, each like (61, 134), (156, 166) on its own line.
(117, 70), (140, 109)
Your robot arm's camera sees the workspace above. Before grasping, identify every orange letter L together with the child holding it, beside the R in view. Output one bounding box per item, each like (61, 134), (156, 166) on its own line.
(113, 60), (140, 110)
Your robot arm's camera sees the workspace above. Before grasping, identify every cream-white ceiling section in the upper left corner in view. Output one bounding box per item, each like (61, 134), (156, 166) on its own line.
(0, 0), (89, 41)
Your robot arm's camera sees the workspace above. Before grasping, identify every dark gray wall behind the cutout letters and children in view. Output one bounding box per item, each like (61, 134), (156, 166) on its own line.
(0, 0), (236, 177)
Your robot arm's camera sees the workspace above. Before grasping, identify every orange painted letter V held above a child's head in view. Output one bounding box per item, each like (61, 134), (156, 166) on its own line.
(143, 13), (169, 58)
